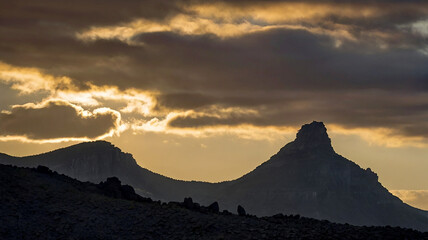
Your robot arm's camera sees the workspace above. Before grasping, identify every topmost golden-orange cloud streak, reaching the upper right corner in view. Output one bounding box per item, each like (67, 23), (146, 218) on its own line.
(76, 1), (428, 48)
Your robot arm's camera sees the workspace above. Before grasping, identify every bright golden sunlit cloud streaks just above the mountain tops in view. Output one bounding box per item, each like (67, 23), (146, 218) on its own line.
(0, 59), (428, 148)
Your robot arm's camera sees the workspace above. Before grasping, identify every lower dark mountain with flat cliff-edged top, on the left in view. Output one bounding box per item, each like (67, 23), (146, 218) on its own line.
(0, 141), (215, 201)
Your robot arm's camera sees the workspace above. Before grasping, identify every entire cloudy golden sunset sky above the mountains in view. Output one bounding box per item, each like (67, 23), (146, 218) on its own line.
(0, 0), (428, 209)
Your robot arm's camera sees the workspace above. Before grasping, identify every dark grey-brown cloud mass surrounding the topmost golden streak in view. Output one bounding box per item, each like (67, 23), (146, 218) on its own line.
(0, 1), (427, 92)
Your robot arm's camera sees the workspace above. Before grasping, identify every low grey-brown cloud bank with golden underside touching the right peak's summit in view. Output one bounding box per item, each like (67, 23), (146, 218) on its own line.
(155, 90), (428, 147)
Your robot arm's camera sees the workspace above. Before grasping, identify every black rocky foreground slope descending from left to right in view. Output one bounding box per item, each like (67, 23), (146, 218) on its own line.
(0, 165), (428, 240)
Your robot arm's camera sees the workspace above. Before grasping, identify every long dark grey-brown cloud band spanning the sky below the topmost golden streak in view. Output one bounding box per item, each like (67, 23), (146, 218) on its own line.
(0, 27), (428, 91)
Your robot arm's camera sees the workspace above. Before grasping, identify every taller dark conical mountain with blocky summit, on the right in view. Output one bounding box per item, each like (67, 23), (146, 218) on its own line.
(214, 122), (422, 228)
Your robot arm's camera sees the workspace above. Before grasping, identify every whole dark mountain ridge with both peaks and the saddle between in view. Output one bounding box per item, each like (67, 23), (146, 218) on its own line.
(0, 122), (428, 231)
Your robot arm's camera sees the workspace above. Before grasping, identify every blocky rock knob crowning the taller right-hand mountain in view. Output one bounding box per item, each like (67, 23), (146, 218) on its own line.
(294, 121), (333, 151)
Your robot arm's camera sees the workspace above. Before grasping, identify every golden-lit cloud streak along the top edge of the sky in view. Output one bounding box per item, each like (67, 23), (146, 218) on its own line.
(76, 2), (428, 48)
